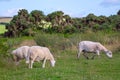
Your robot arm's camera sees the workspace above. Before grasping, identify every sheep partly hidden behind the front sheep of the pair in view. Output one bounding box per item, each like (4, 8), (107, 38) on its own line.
(11, 46), (29, 65)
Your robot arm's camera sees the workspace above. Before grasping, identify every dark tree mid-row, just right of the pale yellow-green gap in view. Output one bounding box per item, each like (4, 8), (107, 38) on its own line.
(46, 11), (72, 32)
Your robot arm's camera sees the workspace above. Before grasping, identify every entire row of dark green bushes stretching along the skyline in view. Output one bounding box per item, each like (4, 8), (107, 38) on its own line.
(5, 9), (120, 37)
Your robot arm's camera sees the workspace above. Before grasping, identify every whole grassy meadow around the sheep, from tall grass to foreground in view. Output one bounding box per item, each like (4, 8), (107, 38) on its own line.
(0, 32), (120, 80)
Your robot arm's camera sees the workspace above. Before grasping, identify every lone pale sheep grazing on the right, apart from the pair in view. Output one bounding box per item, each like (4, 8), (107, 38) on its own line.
(77, 41), (112, 59)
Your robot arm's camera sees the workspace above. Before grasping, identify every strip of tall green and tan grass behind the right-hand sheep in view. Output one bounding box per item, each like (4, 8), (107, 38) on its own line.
(34, 32), (120, 51)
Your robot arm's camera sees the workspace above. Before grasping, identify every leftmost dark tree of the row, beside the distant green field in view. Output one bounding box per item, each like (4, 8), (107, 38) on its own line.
(5, 9), (29, 37)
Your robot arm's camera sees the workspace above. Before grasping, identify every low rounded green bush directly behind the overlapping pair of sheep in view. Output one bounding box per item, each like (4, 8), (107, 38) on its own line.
(34, 33), (71, 50)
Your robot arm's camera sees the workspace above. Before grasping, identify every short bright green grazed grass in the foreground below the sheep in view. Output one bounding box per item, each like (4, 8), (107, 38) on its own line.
(0, 50), (120, 80)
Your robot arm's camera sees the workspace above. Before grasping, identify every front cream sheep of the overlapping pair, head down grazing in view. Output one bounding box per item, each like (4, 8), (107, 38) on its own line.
(28, 46), (55, 68)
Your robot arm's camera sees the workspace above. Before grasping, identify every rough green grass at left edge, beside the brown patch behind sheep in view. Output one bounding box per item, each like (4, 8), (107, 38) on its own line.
(0, 37), (31, 57)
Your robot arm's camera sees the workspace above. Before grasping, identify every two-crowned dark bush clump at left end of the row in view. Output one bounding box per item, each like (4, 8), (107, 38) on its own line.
(5, 9), (44, 37)
